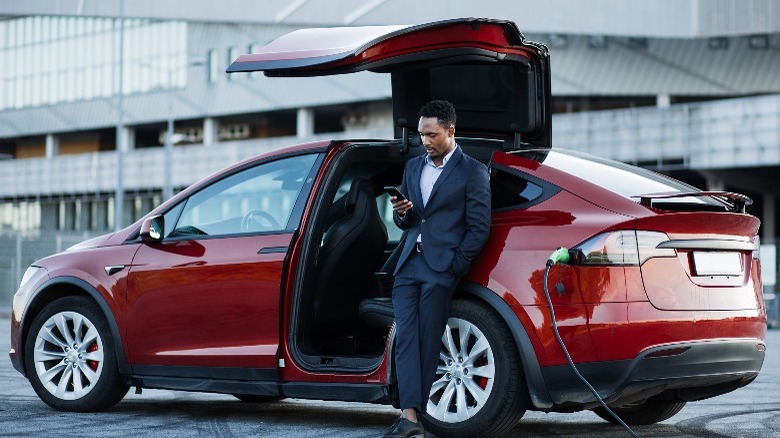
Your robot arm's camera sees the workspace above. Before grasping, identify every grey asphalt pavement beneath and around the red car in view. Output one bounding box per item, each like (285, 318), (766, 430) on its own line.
(0, 316), (780, 438)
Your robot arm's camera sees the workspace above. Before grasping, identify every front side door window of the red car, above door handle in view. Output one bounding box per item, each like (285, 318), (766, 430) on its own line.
(170, 154), (317, 237)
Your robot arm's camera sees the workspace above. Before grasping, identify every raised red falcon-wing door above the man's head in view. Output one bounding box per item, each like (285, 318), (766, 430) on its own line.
(227, 18), (552, 149)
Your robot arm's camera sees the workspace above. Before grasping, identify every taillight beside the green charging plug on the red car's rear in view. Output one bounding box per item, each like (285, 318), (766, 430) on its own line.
(574, 230), (677, 266)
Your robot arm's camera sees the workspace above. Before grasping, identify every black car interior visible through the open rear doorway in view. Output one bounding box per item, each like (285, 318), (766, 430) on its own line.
(290, 136), (502, 372)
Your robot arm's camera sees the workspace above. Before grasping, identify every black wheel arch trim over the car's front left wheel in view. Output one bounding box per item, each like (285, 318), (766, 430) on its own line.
(18, 277), (130, 377)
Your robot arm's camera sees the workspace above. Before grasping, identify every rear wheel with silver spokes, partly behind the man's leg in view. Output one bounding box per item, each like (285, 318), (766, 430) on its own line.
(422, 300), (530, 438)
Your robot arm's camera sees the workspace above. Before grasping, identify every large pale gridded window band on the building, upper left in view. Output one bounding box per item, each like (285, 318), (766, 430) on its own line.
(0, 16), (187, 111)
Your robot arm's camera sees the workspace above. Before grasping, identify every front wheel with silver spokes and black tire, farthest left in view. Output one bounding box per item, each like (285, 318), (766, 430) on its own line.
(24, 296), (130, 412)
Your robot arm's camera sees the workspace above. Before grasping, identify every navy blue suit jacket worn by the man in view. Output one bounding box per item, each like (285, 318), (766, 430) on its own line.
(393, 145), (490, 277)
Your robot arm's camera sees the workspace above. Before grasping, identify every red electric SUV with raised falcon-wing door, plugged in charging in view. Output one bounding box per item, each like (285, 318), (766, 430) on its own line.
(10, 19), (766, 437)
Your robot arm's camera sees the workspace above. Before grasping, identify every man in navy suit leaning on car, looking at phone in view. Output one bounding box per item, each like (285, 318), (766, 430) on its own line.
(385, 100), (490, 438)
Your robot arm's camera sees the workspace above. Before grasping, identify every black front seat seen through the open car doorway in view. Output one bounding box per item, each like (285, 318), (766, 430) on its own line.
(312, 178), (387, 329)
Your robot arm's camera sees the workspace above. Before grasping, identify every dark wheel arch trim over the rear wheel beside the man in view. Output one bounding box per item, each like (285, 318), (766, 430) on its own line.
(454, 282), (553, 408)
